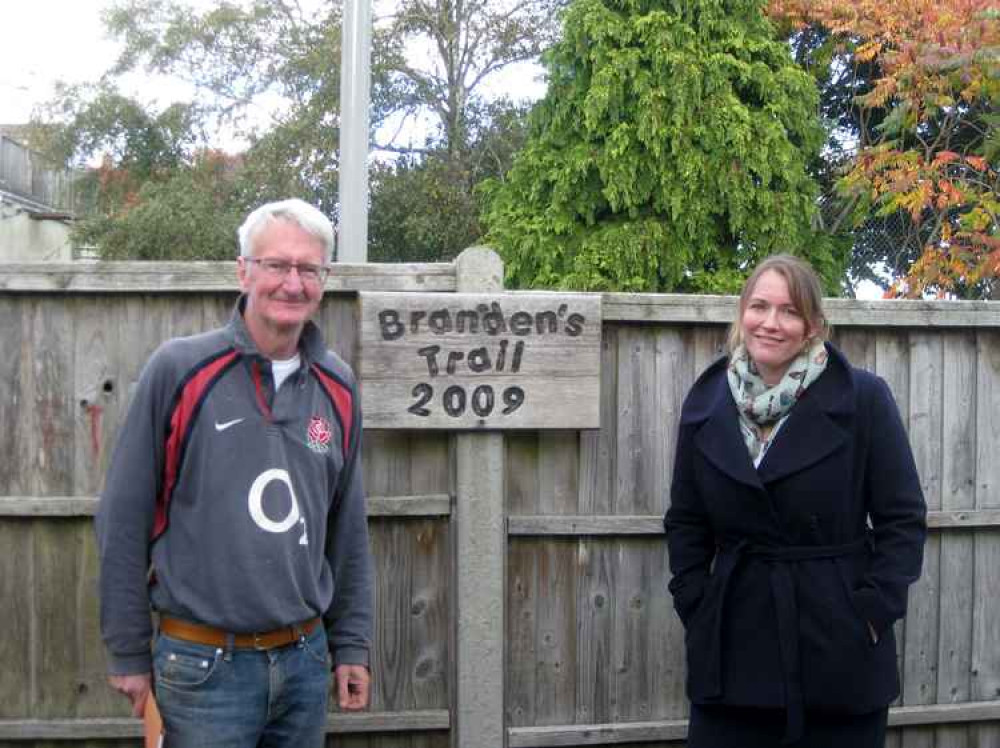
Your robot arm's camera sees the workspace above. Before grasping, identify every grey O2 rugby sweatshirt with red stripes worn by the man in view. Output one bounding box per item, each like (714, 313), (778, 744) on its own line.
(97, 300), (374, 675)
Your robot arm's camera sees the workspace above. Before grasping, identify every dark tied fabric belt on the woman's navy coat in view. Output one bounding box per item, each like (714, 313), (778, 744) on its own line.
(708, 536), (870, 743)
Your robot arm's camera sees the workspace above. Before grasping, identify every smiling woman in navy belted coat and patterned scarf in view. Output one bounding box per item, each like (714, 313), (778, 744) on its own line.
(664, 255), (926, 748)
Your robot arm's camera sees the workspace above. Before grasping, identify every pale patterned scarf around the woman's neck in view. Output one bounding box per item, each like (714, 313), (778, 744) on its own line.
(728, 340), (828, 464)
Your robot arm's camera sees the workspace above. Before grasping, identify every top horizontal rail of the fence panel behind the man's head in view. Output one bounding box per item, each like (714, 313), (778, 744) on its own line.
(0, 261), (455, 298)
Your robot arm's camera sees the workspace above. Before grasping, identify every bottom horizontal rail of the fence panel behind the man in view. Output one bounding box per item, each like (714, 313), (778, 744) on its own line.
(0, 709), (450, 741)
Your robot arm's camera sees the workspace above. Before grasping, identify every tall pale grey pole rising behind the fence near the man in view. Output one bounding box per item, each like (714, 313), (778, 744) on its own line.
(337, 0), (372, 262)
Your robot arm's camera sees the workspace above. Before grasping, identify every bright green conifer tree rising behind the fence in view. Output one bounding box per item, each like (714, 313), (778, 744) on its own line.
(483, 0), (846, 293)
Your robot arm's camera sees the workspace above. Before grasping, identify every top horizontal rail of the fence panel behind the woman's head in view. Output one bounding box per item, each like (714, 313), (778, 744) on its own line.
(602, 293), (1000, 328)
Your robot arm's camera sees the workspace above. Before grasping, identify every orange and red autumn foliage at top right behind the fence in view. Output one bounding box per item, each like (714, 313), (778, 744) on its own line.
(769, 0), (1000, 297)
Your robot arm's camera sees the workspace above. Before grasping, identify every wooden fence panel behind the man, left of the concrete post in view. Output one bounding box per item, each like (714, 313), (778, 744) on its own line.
(0, 264), (452, 748)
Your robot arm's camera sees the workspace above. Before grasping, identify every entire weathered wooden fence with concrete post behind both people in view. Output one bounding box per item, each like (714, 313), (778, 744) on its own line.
(0, 253), (1000, 748)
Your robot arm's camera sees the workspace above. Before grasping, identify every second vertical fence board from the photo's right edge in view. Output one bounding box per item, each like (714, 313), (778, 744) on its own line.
(935, 331), (976, 748)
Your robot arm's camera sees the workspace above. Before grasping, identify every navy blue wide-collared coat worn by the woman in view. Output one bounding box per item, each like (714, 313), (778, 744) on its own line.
(664, 344), (926, 733)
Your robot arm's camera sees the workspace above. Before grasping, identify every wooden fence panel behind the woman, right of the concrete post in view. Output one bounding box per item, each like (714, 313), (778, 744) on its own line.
(507, 295), (1000, 748)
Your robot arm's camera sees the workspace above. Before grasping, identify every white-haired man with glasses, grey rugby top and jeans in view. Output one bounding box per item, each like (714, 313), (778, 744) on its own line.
(97, 200), (373, 748)
